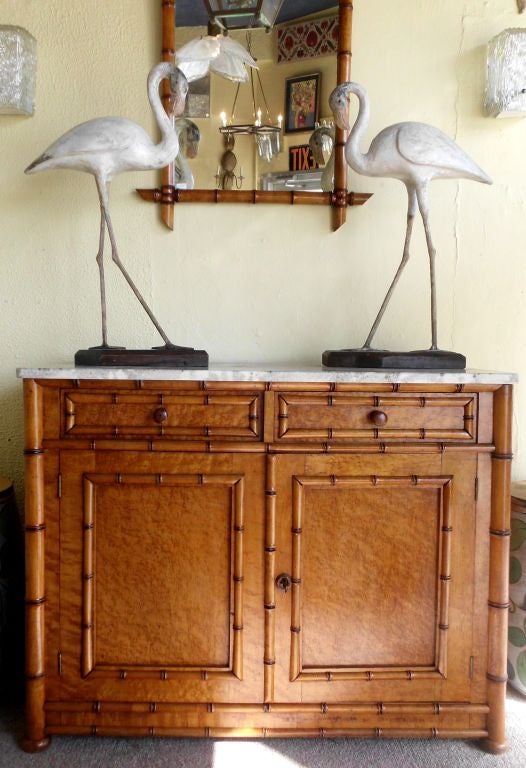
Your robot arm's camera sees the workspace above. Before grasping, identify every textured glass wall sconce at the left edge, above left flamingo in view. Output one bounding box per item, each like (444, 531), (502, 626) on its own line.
(0, 24), (37, 115)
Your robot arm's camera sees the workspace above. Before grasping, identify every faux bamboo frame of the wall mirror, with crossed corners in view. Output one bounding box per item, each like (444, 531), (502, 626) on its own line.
(137, 0), (370, 230)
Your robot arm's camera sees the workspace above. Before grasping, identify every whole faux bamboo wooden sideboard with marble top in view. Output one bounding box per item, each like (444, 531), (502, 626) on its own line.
(19, 367), (515, 752)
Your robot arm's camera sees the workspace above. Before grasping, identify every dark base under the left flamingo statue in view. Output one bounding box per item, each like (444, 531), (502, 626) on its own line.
(75, 344), (208, 368)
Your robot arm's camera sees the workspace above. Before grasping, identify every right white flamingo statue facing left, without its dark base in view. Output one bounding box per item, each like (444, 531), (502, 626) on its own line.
(329, 83), (492, 350)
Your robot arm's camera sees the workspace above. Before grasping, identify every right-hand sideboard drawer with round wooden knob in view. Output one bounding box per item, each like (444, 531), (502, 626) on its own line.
(275, 392), (477, 442)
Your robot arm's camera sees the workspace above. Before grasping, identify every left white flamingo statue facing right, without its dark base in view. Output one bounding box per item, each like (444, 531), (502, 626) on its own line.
(25, 62), (188, 348)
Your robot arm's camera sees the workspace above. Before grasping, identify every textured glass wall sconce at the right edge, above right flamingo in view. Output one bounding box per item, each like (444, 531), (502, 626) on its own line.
(484, 29), (526, 117)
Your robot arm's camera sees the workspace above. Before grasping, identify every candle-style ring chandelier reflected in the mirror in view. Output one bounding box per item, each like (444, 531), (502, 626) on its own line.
(219, 38), (283, 161)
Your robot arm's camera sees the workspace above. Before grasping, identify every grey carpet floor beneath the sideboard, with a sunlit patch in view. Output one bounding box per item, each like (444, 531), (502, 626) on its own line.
(0, 691), (526, 768)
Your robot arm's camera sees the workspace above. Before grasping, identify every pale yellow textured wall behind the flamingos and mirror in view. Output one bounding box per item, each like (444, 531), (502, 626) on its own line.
(0, 0), (526, 496)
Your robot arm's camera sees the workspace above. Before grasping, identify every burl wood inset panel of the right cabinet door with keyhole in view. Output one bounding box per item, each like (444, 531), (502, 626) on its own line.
(292, 476), (451, 674)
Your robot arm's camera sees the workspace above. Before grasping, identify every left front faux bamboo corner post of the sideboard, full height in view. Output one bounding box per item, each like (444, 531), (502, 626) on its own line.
(22, 380), (51, 752)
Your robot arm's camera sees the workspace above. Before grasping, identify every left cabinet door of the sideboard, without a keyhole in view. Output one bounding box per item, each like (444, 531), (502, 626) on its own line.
(53, 452), (263, 701)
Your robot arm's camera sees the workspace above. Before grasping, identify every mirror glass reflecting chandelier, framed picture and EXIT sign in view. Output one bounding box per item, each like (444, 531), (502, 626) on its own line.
(174, 0), (338, 191)
